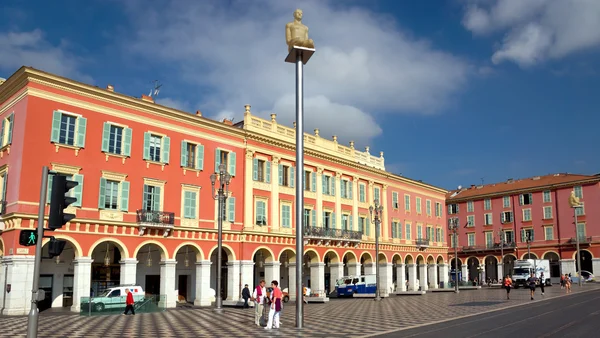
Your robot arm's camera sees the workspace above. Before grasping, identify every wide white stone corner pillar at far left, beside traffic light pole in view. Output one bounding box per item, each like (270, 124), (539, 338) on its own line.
(0, 256), (35, 315)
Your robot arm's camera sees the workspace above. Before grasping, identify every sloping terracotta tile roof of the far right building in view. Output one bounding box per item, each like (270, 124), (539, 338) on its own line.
(446, 173), (600, 202)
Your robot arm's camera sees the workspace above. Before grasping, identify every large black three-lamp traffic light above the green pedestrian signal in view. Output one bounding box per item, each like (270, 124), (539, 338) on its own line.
(48, 175), (79, 231)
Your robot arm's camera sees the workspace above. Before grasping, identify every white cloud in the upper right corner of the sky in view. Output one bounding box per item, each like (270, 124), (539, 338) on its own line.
(463, 0), (600, 68)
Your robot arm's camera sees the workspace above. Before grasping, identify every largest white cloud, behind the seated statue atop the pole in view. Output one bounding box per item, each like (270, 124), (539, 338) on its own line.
(119, 0), (470, 142)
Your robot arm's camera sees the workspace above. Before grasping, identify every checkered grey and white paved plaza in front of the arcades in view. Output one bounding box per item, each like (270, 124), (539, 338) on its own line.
(0, 285), (600, 338)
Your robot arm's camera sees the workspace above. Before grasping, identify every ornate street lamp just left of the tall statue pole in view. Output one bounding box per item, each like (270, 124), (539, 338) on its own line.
(210, 163), (231, 310)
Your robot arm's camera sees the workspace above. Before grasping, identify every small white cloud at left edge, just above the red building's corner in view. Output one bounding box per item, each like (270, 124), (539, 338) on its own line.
(0, 29), (93, 83)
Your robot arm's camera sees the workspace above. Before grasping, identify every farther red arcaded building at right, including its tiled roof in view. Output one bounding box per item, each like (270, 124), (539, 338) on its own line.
(446, 174), (600, 280)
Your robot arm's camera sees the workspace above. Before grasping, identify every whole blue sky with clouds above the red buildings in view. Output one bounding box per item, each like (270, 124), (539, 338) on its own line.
(0, 0), (600, 189)
